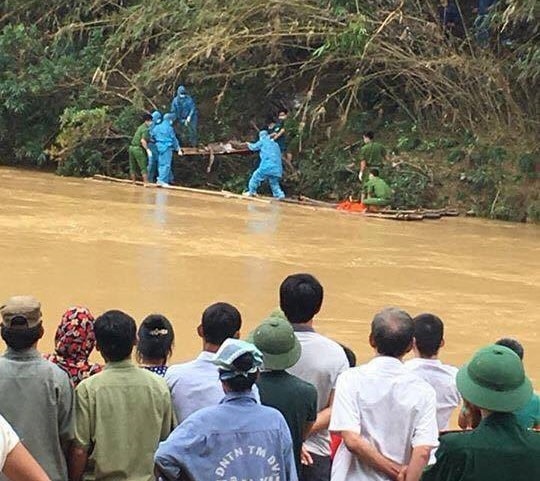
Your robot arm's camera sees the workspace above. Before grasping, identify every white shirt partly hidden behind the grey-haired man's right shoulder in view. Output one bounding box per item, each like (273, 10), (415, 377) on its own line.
(405, 358), (461, 431)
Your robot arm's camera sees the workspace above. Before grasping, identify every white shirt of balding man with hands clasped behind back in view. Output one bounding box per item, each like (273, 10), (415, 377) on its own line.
(330, 356), (439, 481)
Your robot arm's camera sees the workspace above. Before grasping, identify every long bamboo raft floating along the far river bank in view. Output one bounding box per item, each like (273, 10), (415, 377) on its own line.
(90, 174), (459, 221)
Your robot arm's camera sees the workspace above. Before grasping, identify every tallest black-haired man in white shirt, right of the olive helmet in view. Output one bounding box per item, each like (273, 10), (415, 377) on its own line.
(279, 274), (349, 481)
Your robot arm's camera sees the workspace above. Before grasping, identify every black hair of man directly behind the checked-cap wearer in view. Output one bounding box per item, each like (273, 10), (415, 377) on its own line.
(201, 302), (242, 346)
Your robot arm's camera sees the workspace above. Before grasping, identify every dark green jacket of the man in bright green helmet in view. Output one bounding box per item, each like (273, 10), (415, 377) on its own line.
(421, 413), (540, 481)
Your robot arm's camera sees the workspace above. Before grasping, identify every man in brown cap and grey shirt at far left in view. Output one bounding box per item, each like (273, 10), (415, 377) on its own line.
(0, 296), (74, 481)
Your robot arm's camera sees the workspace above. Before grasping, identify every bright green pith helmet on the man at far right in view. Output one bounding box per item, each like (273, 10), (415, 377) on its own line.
(456, 344), (533, 412)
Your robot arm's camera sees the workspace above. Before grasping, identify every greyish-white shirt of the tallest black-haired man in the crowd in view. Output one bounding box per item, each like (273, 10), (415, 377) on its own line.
(287, 324), (349, 456)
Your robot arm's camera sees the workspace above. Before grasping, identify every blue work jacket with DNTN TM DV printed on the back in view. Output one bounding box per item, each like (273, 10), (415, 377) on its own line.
(155, 392), (298, 481)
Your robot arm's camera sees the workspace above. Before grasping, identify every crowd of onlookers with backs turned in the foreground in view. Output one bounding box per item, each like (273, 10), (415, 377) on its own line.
(0, 274), (540, 481)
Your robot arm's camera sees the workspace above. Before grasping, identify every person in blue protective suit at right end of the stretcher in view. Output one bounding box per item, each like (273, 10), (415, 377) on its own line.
(246, 130), (285, 199)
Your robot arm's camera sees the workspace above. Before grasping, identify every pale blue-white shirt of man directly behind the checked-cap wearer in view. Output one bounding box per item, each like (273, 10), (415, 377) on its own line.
(165, 351), (259, 423)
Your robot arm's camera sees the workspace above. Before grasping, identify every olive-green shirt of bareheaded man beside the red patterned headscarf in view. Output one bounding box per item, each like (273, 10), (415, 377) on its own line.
(75, 360), (173, 481)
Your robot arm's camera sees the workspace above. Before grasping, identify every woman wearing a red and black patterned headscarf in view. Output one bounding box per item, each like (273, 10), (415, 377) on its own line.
(45, 307), (101, 387)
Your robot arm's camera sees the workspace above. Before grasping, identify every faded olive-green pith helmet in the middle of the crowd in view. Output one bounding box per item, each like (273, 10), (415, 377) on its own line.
(249, 316), (302, 371)
